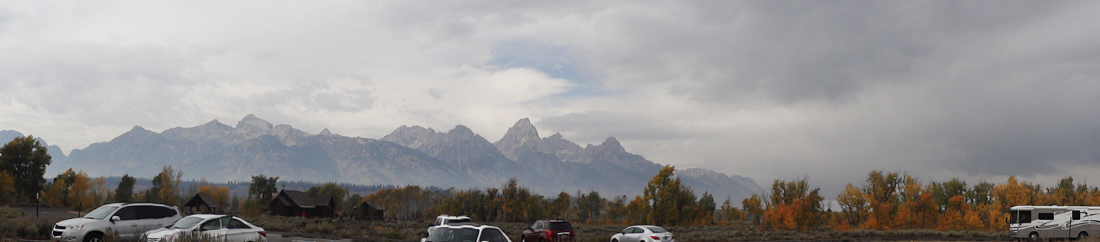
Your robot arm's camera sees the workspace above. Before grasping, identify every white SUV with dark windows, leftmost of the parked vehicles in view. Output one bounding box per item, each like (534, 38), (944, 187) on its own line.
(51, 202), (180, 242)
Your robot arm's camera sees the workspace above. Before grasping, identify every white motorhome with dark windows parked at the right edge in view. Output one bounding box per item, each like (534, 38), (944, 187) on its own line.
(1009, 206), (1100, 241)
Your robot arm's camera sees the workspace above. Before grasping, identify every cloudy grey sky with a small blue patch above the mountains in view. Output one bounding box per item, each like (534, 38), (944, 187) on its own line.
(0, 0), (1100, 193)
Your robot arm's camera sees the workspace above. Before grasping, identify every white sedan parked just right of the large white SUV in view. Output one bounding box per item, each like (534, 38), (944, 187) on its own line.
(144, 215), (267, 242)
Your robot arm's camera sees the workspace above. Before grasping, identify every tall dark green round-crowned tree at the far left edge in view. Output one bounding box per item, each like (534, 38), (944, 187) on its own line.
(0, 135), (53, 199)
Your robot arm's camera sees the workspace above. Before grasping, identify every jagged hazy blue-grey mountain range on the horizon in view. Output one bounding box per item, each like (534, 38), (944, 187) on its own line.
(0, 114), (762, 201)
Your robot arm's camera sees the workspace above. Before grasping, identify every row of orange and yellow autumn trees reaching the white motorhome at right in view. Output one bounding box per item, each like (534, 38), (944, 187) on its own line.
(752, 171), (1100, 231)
